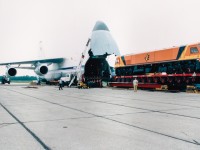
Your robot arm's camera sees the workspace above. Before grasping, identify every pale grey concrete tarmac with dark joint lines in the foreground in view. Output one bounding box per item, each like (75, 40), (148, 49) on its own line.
(0, 84), (200, 150)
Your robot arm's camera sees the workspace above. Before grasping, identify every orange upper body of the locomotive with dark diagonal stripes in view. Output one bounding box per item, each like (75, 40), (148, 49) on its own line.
(115, 44), (200, 68)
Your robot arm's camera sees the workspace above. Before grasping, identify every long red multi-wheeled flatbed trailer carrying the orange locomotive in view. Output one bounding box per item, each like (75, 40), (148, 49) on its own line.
(109, 73), (200, 90)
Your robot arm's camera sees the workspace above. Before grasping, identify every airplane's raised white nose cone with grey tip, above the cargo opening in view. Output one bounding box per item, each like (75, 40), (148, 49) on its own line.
(90, 21), (120, 56)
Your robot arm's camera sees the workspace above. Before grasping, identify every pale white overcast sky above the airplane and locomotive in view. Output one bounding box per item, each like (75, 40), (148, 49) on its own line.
(0, 0), (200, 74)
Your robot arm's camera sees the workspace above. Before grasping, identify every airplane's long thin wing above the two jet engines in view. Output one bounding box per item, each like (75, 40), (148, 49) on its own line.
(0, 58), (64, 66)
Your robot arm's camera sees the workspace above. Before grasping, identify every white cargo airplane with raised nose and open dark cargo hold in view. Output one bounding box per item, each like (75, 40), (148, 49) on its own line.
(0, 21), (120, 85)
